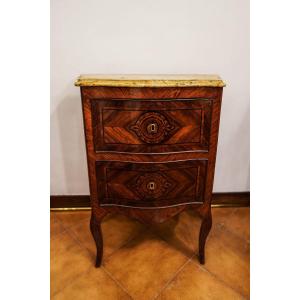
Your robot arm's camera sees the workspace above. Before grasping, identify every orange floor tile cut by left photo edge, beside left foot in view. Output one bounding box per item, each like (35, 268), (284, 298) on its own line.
(50, 231), (94, 295)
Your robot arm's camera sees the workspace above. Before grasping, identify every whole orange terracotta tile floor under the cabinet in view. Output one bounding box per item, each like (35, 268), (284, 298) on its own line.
(51, 208), (250, 300)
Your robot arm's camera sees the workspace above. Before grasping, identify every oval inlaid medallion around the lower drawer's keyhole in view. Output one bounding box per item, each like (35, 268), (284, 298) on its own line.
(127, 173), (176, 199)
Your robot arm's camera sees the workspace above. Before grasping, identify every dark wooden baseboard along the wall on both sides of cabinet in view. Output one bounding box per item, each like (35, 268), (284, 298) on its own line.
(50, 192), (250, 210)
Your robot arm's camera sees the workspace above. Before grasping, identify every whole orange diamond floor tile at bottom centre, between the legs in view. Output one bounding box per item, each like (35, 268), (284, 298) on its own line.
(104, 232), (188, 300)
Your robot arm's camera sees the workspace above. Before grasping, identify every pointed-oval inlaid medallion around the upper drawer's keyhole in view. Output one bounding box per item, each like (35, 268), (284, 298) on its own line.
(129, 112), (179, 144)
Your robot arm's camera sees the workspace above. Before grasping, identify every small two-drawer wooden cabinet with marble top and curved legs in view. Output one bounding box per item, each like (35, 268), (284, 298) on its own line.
(75, 75), (225, 267)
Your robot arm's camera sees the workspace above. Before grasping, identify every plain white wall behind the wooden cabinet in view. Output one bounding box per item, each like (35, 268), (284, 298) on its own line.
(51, 0), (249, 195)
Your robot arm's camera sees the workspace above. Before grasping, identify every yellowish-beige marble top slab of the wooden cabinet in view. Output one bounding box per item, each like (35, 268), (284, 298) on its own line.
(75, 74), (225, 87)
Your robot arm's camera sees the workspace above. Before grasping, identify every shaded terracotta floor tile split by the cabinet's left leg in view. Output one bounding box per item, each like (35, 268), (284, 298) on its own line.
(70, 214), (146, 259)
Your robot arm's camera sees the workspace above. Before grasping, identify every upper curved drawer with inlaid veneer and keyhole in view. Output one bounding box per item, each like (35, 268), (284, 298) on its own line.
(92, 99), (212, 153)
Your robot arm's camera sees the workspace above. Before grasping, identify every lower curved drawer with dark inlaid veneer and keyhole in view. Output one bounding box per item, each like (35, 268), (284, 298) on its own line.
(96, 160), (207, 207)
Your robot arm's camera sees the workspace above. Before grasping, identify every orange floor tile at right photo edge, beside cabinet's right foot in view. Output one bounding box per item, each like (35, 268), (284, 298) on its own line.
(193, 228), (250, 296)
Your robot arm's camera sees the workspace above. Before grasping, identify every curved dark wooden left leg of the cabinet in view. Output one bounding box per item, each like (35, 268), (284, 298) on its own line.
(90, 210), (106, 268)
